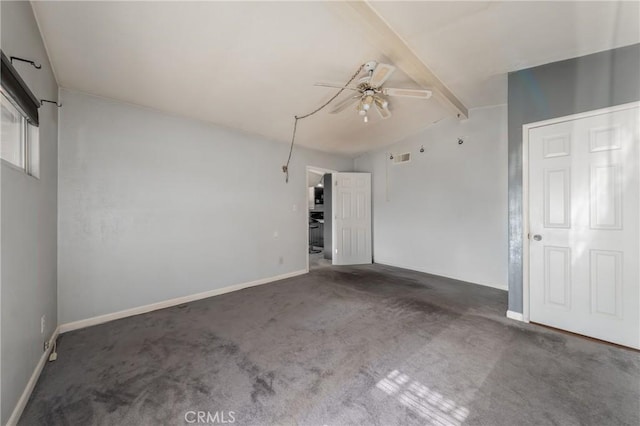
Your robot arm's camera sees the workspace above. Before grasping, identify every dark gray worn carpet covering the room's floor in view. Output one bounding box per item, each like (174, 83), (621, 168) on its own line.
(20, 265), (640, 426)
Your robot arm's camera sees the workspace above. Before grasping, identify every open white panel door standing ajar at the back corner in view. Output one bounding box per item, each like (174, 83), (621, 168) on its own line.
(331, 173), (371, 265)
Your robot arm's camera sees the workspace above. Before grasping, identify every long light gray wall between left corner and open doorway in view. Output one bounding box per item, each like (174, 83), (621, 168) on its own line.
(58, 90), (353, 324)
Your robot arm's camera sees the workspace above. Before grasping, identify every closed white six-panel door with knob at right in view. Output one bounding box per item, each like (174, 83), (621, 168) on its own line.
(528, 105), (640, 348)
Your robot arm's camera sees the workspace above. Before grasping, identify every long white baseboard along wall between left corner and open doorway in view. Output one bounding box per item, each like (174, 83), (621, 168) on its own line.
(59, 270), (308, 334)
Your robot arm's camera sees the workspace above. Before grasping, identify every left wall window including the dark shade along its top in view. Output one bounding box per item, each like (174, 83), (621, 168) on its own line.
(0, 52), (40, 177)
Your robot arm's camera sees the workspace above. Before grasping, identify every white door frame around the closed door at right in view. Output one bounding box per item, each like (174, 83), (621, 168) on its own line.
(514, 101), (640, 322)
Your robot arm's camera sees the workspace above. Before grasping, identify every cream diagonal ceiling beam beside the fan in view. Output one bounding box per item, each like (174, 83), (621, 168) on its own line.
(327, 0), (469, 119)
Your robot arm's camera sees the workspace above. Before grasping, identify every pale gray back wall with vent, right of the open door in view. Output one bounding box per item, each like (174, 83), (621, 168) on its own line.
(355, 105), (507, 290)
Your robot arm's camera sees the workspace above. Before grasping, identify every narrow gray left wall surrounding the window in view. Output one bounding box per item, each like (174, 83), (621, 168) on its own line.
(0, 1), (58, 424)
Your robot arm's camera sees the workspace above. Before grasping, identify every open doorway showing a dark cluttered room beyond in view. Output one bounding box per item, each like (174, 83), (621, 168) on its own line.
(306, 166), (335, 270)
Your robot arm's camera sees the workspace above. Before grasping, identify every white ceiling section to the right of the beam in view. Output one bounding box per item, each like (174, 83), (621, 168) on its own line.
(372, 1), (640, 108)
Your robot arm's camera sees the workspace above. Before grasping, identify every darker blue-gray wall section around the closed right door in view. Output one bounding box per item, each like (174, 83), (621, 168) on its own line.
(509, 44), (640, 312)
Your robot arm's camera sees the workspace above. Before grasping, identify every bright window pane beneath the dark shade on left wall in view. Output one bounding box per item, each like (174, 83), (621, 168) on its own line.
(0, 92), (40, 177)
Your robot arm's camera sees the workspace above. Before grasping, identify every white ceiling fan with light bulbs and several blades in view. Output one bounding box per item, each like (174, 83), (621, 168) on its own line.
(315, 61), (431, 123)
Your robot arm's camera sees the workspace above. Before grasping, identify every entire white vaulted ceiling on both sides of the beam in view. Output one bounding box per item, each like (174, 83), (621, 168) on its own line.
(33, 2), (640, 155)
